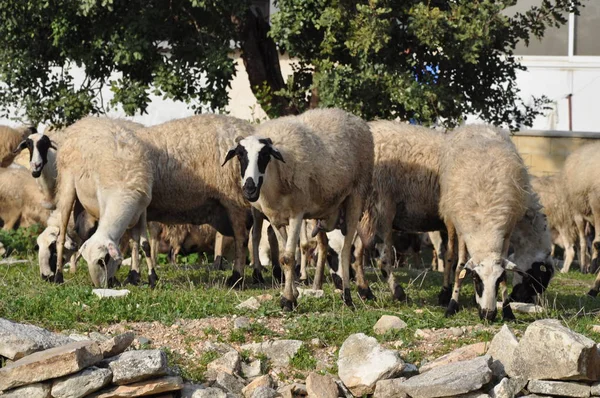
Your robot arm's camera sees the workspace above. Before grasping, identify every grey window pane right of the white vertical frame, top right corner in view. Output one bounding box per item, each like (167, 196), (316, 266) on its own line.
(575, 1), (600, 56)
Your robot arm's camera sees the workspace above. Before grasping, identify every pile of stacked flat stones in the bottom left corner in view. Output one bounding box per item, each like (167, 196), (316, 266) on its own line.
(0, 319), (183, 398)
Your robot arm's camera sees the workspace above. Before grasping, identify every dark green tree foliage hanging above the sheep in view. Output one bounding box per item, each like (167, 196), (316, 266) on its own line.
(0, 0), (580, 129)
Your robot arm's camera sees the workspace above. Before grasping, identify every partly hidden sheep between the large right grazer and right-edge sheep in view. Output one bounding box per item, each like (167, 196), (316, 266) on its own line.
(531, 176), (577, 273)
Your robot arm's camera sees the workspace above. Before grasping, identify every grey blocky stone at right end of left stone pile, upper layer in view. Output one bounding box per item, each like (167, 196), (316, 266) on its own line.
(108, 350), (171, 384)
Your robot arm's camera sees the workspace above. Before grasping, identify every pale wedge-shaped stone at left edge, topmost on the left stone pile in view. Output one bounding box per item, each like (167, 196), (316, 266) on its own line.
(0, 318), (73, 361)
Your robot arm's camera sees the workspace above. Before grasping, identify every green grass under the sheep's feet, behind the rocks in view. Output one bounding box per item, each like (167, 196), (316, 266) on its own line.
(0, 233), (600, 380)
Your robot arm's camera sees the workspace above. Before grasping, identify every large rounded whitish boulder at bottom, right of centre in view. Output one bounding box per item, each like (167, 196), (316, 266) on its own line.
(337, 333), (405, 396)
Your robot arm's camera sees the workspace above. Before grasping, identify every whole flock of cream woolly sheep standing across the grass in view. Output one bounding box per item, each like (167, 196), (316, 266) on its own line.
(0, 109), (600, 320)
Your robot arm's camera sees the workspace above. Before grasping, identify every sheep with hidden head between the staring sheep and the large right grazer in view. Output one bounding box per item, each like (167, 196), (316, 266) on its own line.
(357, 120), (445, 300)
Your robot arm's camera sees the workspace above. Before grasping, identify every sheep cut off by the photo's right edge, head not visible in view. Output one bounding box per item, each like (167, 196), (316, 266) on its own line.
(560, 142), (600, 297)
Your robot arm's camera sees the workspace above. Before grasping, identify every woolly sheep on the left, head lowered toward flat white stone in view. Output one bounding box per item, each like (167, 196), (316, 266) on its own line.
(55, 117), (154, 286)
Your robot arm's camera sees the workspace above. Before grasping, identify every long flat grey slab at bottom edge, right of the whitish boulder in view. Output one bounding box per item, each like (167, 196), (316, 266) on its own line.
(396, 355), (492, 398)
